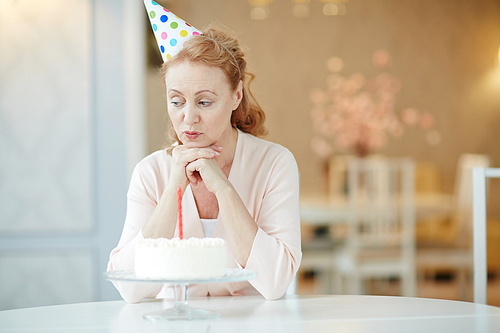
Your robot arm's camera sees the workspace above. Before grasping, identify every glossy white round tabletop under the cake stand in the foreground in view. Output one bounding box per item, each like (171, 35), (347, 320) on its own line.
(0, 295), (500, 333)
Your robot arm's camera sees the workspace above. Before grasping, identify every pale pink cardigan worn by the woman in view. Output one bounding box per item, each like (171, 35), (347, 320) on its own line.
(108, 130), (302, 303)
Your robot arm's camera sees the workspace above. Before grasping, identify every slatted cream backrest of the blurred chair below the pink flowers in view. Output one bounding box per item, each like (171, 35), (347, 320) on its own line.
(348, 157), (415, 250)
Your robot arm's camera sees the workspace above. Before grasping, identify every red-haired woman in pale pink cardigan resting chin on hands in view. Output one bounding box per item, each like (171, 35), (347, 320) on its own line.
(108, 28), (301, 302)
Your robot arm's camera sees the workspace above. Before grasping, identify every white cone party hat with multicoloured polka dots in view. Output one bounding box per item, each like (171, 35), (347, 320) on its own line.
(144, 0), (201, 62)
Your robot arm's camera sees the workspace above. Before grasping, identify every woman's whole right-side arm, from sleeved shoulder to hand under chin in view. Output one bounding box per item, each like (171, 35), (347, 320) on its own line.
(186, 147), (302, 299)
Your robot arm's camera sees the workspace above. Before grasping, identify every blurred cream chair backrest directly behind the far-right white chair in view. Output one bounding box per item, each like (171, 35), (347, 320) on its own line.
(451, 154), (490, 247)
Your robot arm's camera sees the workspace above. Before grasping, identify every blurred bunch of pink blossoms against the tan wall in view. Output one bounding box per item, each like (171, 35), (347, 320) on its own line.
(310, 50), (434, 159)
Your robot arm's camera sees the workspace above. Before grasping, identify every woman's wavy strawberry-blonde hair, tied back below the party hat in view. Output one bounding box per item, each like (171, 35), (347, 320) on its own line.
(161, 25), (267, 143)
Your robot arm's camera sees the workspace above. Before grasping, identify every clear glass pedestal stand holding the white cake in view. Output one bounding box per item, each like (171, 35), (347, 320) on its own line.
(104, 268), (257, 322)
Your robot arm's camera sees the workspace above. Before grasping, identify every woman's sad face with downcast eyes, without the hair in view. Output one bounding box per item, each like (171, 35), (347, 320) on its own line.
(165, 61), (242, 148)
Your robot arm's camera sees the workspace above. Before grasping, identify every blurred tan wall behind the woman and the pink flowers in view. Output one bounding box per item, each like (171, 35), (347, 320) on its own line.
(147, 0), (500, 216)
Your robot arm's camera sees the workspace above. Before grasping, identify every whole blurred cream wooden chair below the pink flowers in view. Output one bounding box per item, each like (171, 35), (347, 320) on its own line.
(335, 157), (416, 296)
